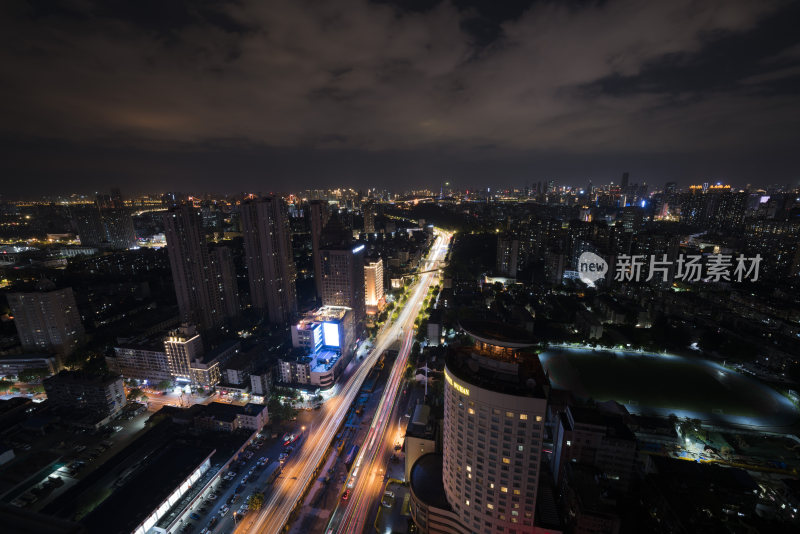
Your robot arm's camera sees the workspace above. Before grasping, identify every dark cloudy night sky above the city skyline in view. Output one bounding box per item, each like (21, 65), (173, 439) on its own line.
(0, 0), (800, 198)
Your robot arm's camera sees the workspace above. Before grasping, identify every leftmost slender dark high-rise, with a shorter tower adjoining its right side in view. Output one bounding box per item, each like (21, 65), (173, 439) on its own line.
(164, 204), (226, 329)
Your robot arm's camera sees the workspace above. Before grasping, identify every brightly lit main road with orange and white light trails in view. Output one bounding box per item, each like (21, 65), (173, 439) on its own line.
(237, 229), (452, 534)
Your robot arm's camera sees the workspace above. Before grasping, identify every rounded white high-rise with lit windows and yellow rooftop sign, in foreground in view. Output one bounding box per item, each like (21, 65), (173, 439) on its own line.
(410, 321), (548, 534)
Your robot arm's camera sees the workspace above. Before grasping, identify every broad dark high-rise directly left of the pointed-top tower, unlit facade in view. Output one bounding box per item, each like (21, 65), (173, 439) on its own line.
(240, 196), (297, 324)
